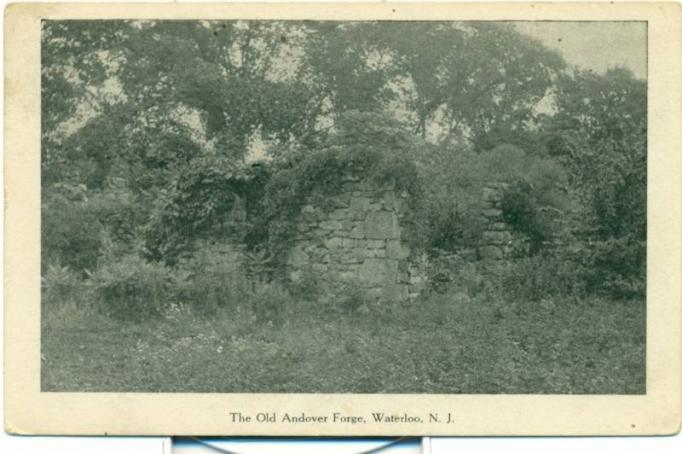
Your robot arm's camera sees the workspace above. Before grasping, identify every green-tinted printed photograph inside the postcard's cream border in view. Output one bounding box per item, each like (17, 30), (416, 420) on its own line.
(40, 19), (647, 395)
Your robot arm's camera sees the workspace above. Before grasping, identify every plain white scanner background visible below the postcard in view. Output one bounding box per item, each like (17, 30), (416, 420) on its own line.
(0, 0), (682, 454)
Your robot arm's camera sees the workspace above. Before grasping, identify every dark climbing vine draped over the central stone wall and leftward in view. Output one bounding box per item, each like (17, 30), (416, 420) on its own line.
(147, 112), (421, 266)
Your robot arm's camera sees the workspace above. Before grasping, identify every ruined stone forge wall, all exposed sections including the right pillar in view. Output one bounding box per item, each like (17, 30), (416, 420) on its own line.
(211, 177), (517, 301)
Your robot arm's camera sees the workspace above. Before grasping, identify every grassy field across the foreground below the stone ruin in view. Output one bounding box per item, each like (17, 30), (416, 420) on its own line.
(41, 295), (646, 394)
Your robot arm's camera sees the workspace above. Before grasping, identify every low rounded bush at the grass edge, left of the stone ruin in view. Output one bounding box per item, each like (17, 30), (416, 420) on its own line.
(92, 255), (177, 321)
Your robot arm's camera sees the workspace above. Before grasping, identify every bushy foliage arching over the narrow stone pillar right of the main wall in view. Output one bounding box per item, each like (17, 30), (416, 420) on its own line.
(418, 144), (566, 252)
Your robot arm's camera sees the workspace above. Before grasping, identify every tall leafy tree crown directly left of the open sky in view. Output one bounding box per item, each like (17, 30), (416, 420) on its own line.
(366, 22), (565, 150)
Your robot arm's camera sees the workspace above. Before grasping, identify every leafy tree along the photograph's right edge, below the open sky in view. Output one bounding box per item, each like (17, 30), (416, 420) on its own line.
(548, 68), (647, 292)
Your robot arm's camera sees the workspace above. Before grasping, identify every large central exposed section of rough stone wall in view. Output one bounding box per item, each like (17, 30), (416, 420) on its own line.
(287, 177), (418, 301)
